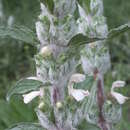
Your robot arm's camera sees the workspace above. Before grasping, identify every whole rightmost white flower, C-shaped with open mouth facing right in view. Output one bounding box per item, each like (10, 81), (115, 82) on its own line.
(111, 81), (129, 104)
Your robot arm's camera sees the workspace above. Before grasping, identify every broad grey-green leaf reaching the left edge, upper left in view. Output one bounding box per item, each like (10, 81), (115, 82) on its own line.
(0, 26), (37, 45)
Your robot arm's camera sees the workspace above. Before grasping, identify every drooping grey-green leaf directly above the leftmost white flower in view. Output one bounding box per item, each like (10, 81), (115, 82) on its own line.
(7, 79), (44, 100)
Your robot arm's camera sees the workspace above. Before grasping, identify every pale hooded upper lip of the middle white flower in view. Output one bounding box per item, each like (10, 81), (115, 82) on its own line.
(70, 73), (86, 83)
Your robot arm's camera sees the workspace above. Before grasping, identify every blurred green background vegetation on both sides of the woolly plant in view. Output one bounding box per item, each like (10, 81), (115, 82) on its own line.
(0, 0), (130, 130)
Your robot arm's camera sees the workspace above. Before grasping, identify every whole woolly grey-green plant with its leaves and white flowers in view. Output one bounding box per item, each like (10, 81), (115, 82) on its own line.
(2, 0), (130, 130)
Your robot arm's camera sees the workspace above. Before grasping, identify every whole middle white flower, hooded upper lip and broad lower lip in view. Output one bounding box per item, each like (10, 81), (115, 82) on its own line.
(68, 73), (89, 101)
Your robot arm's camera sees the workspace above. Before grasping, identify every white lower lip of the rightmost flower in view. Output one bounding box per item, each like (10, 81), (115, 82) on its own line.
(111, 92), (129, 104)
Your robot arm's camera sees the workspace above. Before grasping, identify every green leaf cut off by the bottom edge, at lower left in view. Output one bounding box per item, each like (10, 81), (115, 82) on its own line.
(6, 123), (45, 130)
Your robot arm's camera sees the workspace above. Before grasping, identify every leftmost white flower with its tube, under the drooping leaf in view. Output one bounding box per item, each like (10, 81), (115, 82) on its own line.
(23, 88), (44, 104)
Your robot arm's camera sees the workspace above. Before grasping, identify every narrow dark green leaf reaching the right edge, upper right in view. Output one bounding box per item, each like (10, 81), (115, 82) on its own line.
(107, 23), (130, 39)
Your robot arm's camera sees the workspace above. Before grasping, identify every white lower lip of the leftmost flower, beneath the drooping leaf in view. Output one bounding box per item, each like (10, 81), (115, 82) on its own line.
(23, 91), (40, 104)
